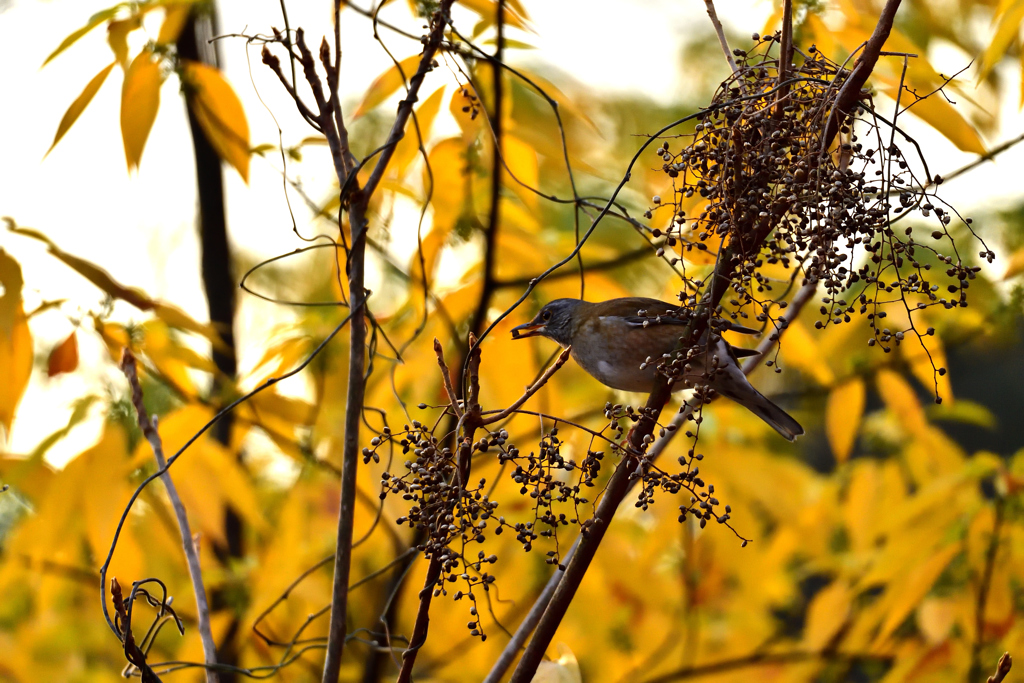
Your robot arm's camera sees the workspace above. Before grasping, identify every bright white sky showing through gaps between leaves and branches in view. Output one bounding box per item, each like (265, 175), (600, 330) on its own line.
(0, 0), (1024, 463)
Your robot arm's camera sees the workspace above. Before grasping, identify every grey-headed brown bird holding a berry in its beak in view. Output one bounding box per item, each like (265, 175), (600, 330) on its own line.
(512, 297), (804, 441)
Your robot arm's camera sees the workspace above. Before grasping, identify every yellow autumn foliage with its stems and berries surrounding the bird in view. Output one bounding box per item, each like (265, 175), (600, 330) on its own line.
(0, 0), (1024, 683)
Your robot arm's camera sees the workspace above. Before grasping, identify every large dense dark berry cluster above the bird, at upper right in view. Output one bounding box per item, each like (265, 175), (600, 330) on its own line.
(646, 34), (994, 397)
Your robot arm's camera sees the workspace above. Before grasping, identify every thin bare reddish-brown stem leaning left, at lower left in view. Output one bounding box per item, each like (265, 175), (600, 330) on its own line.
(120, 348), (218, 683)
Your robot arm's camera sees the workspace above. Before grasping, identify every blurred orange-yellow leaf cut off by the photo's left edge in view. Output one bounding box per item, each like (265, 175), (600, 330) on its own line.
(0, 249), (32, 434)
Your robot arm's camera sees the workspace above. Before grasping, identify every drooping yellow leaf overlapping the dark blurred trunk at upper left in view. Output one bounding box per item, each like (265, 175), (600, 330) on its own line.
(182, 60), (249, 182)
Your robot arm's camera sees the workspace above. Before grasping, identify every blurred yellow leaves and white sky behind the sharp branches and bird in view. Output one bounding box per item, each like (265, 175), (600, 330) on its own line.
(0, 0), (1024, 682)
